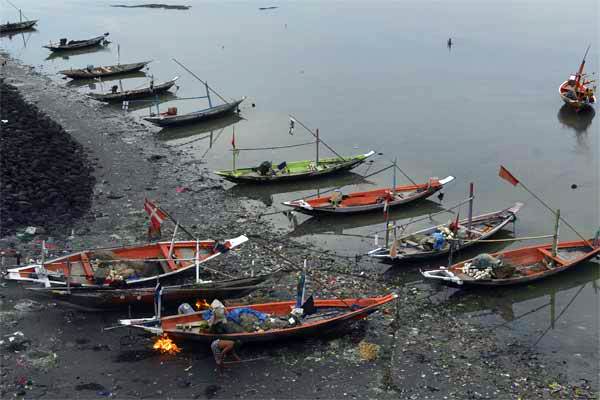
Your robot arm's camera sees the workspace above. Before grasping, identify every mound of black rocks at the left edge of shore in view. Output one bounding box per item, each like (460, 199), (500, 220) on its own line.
(0, 81), (94, 236)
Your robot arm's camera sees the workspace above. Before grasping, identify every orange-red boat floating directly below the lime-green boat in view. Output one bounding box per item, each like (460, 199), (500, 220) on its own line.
(283, 176), (454, 215)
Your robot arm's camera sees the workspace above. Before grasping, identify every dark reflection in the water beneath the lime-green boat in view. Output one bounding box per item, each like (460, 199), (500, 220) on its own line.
(227, 172), (372, 206)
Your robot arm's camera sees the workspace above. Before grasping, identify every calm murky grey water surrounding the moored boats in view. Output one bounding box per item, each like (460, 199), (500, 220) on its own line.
(0, 0), (600, 377)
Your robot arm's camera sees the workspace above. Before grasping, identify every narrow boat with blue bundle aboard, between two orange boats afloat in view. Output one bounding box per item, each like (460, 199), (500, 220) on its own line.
(368, 203), (523, 261)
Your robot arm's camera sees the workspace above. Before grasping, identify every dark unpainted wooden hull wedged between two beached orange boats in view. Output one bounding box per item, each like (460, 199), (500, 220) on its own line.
(27, 271), (279, 310)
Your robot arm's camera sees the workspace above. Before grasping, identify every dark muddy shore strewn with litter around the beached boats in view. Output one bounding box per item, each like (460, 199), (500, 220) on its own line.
(0, 56), (597, 399)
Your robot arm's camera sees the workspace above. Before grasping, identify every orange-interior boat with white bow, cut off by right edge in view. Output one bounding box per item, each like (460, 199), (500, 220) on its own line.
(421, 238), (600, 287)
